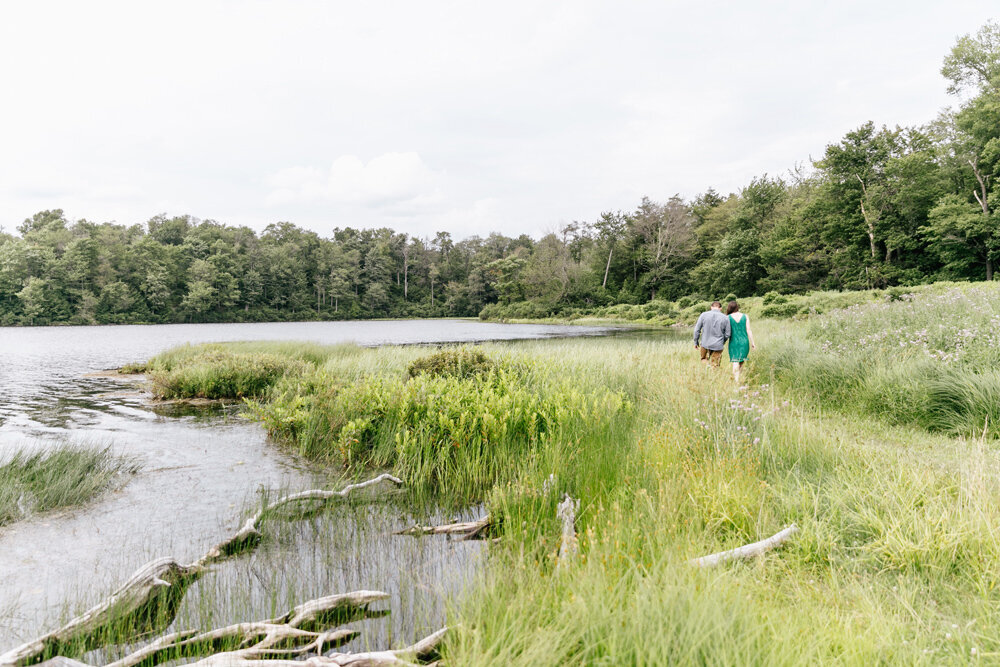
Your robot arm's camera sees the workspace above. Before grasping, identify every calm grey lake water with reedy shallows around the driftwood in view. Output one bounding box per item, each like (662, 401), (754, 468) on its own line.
(0, 320), (608, 653)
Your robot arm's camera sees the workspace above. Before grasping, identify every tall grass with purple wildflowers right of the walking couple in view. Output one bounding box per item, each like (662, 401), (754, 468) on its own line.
(752, 284), (1000, 437)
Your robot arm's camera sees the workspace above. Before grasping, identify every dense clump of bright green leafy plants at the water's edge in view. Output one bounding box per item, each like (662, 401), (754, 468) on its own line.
(252, 349), (632, 497)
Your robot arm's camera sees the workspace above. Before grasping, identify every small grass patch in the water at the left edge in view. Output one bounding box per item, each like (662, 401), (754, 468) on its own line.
(0, 445), (136, 527)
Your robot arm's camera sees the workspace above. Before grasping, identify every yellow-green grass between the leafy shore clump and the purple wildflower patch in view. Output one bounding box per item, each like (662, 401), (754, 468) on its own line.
(446, 343), (1000, 665)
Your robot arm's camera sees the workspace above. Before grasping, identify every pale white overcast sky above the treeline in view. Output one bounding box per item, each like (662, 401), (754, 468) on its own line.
(0, 0), (998, 238)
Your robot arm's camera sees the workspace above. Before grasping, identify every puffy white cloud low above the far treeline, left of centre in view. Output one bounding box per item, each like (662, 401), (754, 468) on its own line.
(266, 152), (443, 209)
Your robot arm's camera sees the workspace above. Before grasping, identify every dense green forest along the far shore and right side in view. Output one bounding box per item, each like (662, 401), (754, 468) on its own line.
(0, 22), (1000, 325)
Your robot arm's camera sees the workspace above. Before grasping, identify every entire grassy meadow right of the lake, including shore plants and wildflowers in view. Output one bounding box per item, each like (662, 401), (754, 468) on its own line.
(143, 285), (1000, 665)
